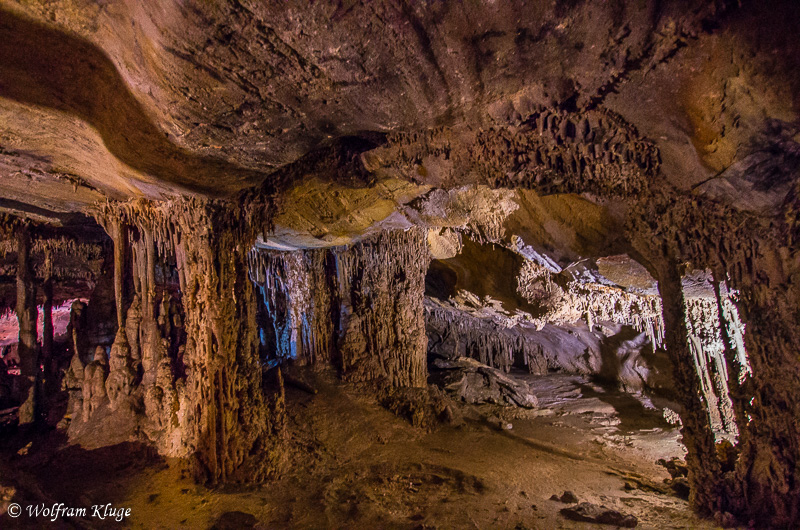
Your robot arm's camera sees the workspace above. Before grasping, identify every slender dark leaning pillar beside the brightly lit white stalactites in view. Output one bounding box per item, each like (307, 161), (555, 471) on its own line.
(656, 259), (721, 513)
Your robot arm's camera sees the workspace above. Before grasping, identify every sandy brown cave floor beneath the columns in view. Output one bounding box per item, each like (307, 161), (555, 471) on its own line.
(0, 372), (714, 528)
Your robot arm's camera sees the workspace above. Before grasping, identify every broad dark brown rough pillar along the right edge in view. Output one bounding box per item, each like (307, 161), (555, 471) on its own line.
(729, 267), (800, 528)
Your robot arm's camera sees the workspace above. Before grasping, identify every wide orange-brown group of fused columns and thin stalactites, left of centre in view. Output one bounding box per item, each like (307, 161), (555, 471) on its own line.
(96, 201), (282, 482)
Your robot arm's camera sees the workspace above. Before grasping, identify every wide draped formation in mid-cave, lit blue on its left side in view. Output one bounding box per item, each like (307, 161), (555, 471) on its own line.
(250, 229), (429, 387)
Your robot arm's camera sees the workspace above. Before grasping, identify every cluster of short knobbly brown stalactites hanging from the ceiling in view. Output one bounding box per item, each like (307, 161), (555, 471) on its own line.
(376, 107), (661, 197)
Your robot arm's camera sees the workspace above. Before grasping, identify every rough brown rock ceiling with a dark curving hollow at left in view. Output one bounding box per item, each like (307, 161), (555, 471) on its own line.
(0, 0), (800, 223)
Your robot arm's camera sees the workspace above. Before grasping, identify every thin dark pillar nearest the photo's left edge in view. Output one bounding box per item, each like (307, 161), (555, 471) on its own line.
(16, 226), (39, 425)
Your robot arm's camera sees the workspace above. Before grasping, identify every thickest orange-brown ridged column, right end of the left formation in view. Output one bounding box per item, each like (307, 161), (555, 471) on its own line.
(175, 220), (284, 483)
